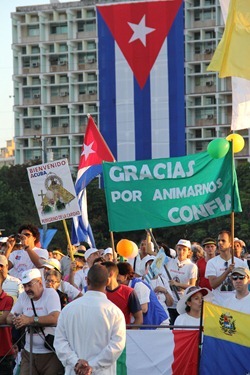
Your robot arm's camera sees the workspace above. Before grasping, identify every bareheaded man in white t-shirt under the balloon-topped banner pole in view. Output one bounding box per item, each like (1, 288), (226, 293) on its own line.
(205, 230), (246, 305)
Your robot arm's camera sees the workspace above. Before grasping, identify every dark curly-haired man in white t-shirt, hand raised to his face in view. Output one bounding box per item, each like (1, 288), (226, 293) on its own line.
(5, 224), (49, 280)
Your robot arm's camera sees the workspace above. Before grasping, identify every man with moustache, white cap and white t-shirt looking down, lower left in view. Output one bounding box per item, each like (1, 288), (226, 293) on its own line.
(7, 268), (64, 375)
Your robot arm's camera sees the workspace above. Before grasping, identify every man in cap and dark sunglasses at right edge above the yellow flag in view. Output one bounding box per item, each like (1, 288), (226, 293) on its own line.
(223, 267), (250, 314)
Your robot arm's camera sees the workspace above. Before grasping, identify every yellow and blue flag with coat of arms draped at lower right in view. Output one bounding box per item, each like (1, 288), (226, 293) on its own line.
(200, 302), (250, 375)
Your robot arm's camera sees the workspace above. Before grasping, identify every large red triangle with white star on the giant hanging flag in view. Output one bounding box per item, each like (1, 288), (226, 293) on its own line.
(97, 0), (182, 89)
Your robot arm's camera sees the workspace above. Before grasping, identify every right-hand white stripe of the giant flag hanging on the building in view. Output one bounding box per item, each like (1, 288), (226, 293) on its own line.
(150, 38), (170, 159)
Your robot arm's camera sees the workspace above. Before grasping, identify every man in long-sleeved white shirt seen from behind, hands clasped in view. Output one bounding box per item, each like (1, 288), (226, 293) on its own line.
(54, 264), (126, 375)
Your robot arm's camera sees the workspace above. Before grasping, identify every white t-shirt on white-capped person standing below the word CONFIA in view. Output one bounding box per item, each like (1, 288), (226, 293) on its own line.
(162, 258), (198, 309)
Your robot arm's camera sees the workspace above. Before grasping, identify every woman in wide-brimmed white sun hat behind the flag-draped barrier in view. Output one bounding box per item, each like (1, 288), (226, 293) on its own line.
(174, 286), (209, 326)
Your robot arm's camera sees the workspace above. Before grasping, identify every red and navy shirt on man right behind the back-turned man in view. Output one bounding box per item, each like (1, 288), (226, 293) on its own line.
(106, 284), (141, 324)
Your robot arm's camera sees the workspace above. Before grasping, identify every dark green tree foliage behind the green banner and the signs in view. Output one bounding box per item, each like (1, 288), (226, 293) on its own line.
(0, 163), (250, 250)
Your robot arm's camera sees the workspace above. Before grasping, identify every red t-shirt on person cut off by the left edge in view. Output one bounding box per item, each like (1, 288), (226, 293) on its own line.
(0, 292), (14, 357)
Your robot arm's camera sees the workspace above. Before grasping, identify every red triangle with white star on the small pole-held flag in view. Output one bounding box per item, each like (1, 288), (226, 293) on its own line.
(78, 116), (115, 170)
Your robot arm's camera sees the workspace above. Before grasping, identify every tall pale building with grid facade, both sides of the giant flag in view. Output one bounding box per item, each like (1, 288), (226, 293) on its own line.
(11, 0), (250, 172)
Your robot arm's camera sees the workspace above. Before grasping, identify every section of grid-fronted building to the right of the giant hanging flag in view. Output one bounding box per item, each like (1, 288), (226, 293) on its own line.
(185, 0), (250, 162)
